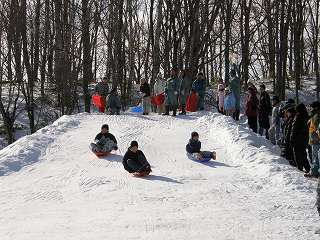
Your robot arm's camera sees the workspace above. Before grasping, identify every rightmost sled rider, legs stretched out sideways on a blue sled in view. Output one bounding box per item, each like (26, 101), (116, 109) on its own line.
(186, 132), (216, 161)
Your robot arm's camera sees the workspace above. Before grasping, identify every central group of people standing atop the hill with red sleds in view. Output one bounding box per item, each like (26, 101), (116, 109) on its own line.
(140, 68), (207, 116)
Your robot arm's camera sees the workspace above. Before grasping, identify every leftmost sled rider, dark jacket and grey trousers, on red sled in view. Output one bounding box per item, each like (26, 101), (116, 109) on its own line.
(90, 124), (118, 153)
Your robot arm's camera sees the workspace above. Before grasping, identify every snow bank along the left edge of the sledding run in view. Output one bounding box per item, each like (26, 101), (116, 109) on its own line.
(0, 116), (80, 176)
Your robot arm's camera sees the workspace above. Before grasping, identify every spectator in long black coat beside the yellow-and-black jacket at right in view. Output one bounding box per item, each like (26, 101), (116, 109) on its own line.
(290, 103), (311, 173)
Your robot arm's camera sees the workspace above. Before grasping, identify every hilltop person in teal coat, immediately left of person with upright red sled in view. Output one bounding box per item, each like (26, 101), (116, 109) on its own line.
(179, 70), (192, 115)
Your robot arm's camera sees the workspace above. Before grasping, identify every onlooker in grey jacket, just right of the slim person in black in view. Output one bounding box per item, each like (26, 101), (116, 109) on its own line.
(268, 96), (281, 145)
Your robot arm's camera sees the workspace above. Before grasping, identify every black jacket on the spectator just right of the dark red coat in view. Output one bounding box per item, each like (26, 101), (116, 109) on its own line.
(259, 91), (272, 129)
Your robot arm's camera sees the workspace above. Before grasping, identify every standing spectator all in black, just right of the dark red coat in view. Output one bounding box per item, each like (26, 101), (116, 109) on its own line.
(258, 84), (272, 139)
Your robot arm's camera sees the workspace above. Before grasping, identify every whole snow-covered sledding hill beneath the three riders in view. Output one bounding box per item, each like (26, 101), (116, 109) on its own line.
(0, 113), (320, 240)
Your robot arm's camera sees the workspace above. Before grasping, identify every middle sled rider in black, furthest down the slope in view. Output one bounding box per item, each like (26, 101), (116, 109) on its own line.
(122, 141), (152, 175)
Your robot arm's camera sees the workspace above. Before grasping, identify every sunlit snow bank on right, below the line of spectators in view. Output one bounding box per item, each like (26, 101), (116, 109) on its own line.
(198, 113), (315, 192)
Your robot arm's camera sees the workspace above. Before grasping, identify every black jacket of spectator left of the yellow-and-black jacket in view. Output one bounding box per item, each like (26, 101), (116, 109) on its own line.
(290, 114), (309, 146)
